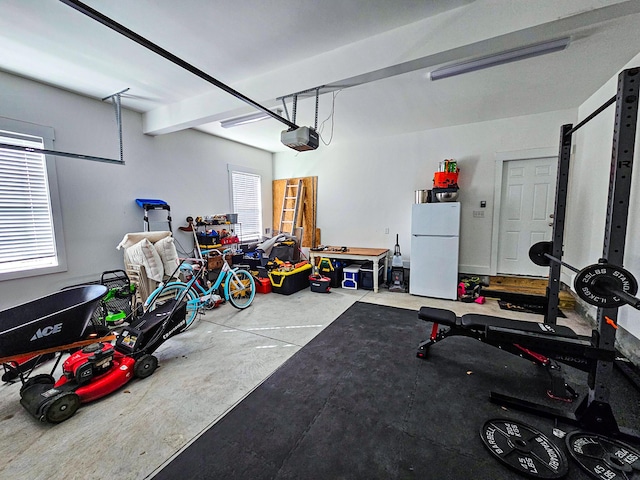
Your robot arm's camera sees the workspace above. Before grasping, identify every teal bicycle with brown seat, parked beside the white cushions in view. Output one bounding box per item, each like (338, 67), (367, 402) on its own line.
(144, 250), (256, 330)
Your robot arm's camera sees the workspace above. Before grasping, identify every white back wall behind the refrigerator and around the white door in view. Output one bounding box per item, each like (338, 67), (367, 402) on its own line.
(274, 110), (576, 274)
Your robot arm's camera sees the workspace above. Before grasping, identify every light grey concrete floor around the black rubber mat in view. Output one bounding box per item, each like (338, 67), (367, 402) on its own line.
(0, 289), (591, 480)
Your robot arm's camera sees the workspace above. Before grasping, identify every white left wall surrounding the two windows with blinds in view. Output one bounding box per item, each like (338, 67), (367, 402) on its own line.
(0, 72), (272, 310)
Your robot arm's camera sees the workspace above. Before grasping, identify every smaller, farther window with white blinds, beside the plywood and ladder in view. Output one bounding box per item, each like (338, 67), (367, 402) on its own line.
(229, 170), (262, 242)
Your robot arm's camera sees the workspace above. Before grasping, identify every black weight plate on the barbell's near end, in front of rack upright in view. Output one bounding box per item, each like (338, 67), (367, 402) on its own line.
(573, 263), (638, 308)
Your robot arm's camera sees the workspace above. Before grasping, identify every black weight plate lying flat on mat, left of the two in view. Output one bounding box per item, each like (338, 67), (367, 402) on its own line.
(480, 418), (569, 478)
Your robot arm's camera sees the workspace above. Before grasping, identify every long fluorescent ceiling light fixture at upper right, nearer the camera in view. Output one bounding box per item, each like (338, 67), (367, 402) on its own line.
(430, 37), (571, 80)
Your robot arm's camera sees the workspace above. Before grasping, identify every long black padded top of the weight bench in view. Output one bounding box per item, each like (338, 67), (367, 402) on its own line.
(418, 307), (578, 339)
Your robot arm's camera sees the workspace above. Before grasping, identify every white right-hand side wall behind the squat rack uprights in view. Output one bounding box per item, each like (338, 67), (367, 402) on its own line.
(564, 55), (640, 338)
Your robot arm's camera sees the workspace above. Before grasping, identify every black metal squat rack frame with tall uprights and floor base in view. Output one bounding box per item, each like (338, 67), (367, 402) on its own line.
(510, 68), (640, 441)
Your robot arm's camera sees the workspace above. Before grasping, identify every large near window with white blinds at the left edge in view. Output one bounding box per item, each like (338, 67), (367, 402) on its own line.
(0, 130), (58, 274)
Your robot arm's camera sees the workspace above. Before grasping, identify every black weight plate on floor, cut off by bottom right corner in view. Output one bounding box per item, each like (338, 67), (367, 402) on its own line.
(566, 431), (640, 480)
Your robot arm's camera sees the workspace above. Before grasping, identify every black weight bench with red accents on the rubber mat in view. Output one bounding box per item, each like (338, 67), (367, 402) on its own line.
(417, 307), (590, 401)
